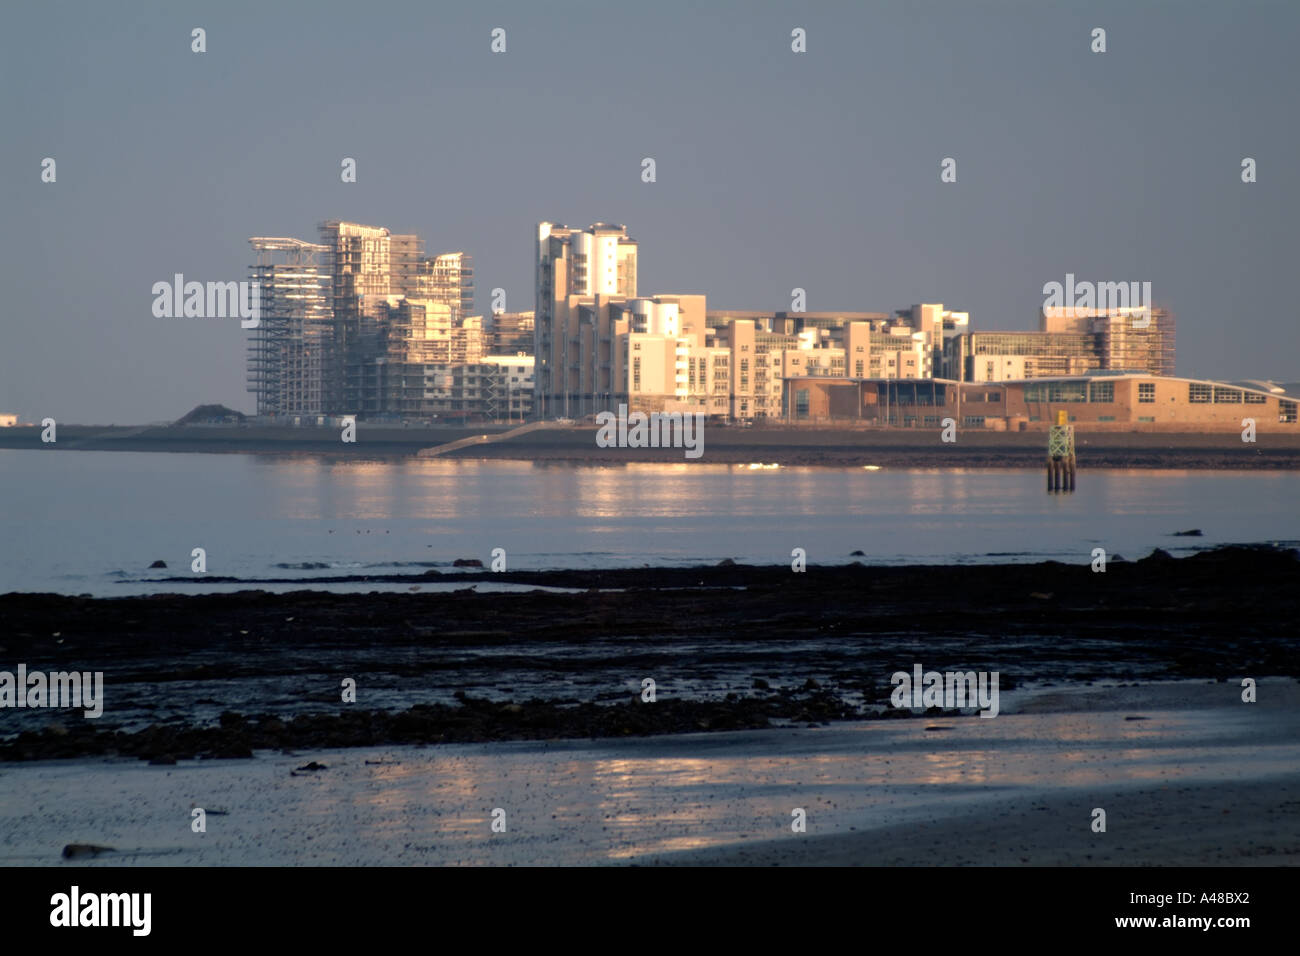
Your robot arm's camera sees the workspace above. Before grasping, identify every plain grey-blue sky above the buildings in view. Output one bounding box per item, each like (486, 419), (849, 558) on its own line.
(0, 0), (1300, 424)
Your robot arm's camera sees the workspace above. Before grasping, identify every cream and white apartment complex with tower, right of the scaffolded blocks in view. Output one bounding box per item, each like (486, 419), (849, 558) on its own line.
(534, 222), (970, 419)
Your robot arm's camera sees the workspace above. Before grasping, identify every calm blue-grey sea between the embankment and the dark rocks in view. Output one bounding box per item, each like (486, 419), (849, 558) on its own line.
(0, 450), (1300, 596)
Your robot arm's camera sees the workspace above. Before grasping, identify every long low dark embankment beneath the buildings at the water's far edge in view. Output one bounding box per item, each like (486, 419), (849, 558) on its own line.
(0, 421), (1300, 471)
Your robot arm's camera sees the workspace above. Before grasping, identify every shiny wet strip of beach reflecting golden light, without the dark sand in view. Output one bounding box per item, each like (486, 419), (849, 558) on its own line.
(0, 702), (1300, 865)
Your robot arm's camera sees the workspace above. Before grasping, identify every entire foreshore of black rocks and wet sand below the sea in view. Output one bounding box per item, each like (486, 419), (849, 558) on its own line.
(0, 548), (1300, 866)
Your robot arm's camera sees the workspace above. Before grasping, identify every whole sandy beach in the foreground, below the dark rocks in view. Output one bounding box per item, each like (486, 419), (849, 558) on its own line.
(0, 679), (1300, 866)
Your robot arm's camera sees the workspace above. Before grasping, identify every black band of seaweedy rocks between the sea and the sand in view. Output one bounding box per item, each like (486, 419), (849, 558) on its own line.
(0, 548), (1300, 760)
